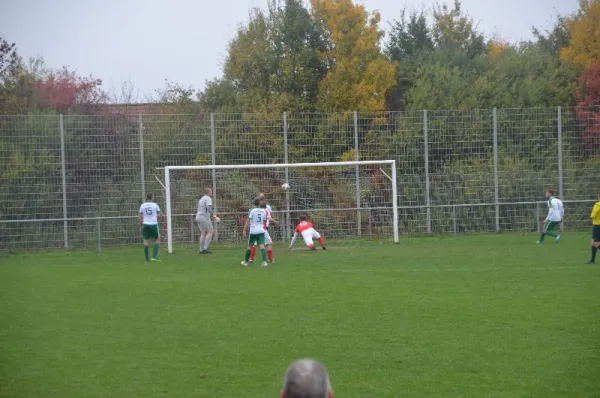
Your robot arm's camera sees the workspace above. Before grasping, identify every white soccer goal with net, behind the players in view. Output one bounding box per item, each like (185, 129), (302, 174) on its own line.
(161, 160), (398, 253)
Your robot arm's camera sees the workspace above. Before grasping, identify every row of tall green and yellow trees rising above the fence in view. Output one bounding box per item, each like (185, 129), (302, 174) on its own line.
(207, 0), (600, 112)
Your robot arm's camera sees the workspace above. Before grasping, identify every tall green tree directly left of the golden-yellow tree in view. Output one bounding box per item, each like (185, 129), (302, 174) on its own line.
(217, 0), (326, 111)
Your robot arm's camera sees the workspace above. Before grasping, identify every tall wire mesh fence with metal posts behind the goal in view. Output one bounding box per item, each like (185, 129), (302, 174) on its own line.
(0, 107), (600, 250)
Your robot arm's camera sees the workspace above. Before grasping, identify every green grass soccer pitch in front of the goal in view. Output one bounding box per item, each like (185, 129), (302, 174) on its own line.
(0, 234), (600, 398)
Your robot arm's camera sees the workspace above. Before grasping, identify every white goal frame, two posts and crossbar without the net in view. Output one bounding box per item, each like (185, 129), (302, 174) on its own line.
(157, 160), (399, 253)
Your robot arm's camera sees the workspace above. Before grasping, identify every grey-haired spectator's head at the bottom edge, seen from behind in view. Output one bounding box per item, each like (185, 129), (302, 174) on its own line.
(281, 359), (333, 398)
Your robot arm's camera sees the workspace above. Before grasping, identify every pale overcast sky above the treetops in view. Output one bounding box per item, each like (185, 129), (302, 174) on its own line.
(0, 0), (577, 96)
